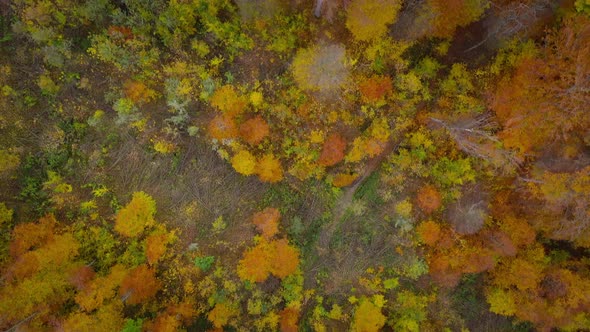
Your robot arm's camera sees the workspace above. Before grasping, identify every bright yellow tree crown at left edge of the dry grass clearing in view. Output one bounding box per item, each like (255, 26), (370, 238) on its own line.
(115, 191), (156, 237)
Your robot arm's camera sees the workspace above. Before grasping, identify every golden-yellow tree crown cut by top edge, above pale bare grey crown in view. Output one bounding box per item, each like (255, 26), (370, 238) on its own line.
(346, 0), (401, 41)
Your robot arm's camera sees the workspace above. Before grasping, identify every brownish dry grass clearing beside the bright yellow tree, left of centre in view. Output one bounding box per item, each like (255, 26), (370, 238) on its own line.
(107, 137), (267, 253)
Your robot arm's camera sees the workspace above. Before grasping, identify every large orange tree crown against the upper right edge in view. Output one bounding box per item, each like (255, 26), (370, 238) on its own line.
(491, 15), (590, 155)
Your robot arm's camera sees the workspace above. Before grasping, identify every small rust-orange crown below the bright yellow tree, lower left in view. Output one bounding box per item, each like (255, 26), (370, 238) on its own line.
(119, 264), (161, 304)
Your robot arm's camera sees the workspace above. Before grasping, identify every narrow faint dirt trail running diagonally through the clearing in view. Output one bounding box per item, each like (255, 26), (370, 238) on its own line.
(317, 140), (399, 256)
